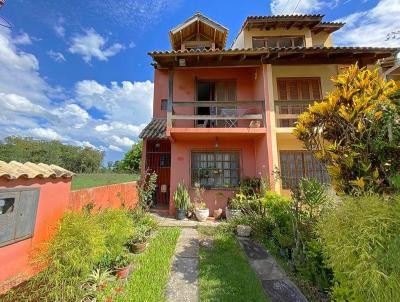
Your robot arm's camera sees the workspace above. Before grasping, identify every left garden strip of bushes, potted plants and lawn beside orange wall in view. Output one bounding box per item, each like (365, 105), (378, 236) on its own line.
(0, 209), (180, 302)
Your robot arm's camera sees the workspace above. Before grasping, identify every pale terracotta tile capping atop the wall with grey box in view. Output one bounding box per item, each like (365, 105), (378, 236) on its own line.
(0, 161), (74, 180)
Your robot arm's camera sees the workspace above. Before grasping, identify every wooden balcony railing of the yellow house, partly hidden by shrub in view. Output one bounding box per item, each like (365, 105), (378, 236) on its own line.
(275, 100), (314, 128)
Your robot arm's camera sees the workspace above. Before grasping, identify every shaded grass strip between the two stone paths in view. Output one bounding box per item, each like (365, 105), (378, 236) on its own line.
(199, 228), (268, 302)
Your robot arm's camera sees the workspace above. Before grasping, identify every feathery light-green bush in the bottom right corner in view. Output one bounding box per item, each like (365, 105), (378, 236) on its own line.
(318, 195), (400, 301)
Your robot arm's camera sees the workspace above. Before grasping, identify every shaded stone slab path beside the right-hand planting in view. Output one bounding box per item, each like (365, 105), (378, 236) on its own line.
(238, 237), (307, 302)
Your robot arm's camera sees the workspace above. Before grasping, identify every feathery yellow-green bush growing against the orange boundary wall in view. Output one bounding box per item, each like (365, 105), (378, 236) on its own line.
(6, 209), (133, 301)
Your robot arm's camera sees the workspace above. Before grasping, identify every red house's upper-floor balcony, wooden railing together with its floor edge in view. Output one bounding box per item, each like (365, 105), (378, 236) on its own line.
(167, 100), (266, 138)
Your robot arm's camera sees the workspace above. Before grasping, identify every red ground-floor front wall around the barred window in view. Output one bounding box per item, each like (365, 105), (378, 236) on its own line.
(170, 138), (257, 215)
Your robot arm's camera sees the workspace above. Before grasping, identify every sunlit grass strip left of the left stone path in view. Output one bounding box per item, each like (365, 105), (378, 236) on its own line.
(115, 228), (180, 302)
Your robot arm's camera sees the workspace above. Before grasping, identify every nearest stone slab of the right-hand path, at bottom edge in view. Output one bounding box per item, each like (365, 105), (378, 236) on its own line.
(261, 279), (307, 302)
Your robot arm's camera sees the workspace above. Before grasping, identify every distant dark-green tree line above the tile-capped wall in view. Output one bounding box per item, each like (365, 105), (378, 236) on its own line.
(0, 137), (104, 173)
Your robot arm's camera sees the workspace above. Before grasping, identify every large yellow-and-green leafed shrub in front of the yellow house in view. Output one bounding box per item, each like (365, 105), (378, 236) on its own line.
(294, 65), (400, 194)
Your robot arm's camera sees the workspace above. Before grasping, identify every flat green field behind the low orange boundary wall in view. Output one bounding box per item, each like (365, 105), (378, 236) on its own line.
(72, 173), (139, 190)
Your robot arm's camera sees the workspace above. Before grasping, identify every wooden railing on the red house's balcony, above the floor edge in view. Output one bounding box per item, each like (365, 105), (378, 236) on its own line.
(167, 100), (265, 128)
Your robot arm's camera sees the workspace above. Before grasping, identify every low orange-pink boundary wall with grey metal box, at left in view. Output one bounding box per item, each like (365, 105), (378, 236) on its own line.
(0, 179), (138, 294)
